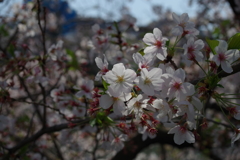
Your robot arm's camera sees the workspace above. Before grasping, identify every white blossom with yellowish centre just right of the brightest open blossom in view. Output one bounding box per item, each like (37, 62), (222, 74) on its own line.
(135, 68), (163, 96)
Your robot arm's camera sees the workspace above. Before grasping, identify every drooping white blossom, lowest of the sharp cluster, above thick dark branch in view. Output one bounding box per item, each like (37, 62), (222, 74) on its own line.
(168, 125), (195, 145)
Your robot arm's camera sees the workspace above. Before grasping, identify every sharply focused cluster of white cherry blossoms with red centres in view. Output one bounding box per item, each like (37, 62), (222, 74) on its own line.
(86, 13), (239, 145)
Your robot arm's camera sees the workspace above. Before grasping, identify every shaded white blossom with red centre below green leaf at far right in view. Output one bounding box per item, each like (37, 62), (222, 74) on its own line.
(212, 40), (239, 73)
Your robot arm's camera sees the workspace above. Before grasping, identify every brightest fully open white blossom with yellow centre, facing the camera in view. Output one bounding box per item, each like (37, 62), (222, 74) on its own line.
(103, 63), (137, 97)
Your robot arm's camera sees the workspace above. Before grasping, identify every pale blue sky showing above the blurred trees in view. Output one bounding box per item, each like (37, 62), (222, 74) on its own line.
(0, 0), (231, 26)
